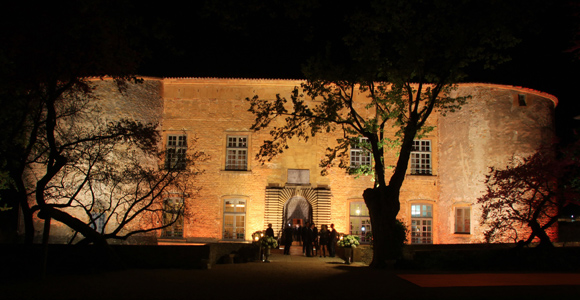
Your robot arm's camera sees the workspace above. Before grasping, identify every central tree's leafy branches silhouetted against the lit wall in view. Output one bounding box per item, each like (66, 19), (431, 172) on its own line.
(248, 80), (467, 186)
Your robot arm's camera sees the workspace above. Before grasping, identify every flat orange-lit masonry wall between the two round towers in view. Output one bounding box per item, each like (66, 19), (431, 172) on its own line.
(163, 78), (438, 241)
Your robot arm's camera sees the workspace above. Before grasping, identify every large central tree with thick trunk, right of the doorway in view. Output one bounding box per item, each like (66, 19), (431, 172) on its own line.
(249, 0), (532, 266)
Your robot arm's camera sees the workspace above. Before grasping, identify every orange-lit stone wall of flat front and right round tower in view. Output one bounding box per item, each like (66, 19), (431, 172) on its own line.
(163, 78), (555, 243)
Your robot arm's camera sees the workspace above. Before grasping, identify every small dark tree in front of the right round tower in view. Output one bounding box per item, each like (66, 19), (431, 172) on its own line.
(477, 145), (580, 248)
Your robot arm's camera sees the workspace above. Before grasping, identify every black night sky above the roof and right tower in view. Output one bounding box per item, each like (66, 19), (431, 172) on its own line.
(135, 5), (580, 141)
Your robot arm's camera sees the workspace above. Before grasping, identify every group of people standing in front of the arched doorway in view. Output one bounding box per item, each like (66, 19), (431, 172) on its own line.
(282, 222), (338, 257)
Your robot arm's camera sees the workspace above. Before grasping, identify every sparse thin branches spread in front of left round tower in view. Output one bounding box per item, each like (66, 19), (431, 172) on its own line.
(28, 87), (205, 243)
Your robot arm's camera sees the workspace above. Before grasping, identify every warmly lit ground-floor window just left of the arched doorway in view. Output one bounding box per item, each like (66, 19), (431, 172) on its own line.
(223, 199), (246, 240)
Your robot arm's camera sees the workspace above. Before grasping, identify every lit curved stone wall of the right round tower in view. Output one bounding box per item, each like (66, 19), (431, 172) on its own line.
(436, 84), (556, 243)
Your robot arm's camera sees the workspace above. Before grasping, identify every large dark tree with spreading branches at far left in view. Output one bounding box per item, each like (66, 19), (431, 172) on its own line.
(0, 0), (198, 248)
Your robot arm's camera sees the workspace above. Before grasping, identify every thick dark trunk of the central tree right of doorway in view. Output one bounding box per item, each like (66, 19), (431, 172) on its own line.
(363, 186), (401, 268)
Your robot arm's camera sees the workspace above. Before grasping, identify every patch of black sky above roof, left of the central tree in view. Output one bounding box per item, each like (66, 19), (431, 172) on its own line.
(141, 5), (311, 79)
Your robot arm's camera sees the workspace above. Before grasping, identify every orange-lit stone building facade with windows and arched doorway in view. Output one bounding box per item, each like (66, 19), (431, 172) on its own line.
(27, 78), (557, 244)
